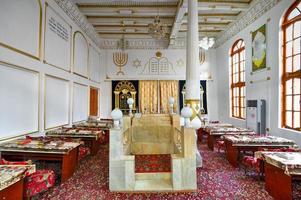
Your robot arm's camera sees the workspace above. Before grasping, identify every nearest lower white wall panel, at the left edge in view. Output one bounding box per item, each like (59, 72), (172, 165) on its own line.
(0, 63), (39, 139)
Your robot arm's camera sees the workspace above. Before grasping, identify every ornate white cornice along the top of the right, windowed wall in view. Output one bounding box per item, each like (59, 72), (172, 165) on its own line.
(215, 0), (282, 48)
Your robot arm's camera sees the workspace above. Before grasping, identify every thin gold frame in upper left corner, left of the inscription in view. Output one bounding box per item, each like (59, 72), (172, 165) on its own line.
(0, 0), (43, 60)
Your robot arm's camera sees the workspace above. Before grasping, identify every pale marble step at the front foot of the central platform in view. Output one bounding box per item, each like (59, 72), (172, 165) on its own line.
(134, 179), (173, 192)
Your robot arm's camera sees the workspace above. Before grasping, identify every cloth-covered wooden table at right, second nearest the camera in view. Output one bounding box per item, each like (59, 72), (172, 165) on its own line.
(225, 135), (295, 167)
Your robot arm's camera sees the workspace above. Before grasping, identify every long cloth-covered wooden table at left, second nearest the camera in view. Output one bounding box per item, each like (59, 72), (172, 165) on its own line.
(0, 140), (80, 182)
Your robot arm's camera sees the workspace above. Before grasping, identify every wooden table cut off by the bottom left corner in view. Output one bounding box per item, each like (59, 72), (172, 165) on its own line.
(0, 165), (26, 200)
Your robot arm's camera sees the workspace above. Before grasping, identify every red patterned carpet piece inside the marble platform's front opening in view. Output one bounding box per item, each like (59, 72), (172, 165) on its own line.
(135, 154), (171, 173)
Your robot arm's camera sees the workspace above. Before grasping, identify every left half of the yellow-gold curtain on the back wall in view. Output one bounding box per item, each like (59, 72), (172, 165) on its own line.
(139, 81), (158, 114)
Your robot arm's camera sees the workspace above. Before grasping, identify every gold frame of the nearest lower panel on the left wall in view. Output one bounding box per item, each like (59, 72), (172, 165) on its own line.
(0, 61), (41, 142)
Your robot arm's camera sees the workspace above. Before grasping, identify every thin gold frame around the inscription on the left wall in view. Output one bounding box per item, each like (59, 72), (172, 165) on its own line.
(43, 1), (72, 72)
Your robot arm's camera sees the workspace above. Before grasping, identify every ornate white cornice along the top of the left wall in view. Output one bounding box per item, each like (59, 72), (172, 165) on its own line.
(54, 0), (100, 46)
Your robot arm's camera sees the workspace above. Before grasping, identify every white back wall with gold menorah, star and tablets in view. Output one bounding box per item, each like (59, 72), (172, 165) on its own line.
(100, 49), (218, 119)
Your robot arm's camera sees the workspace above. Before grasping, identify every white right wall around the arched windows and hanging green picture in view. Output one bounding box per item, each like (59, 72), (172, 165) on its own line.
(216, 0), (301, 145)
